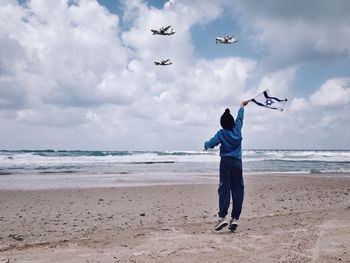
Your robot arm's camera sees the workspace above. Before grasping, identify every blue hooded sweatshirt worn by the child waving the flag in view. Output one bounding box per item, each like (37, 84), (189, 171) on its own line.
(204, 107), (244, 159)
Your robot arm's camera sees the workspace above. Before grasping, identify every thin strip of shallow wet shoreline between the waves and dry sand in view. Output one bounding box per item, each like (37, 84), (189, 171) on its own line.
(0, 172), (350, 191)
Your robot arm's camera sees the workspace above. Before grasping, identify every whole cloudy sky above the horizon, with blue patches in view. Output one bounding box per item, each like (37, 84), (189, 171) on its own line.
(0, 0), (350, 150)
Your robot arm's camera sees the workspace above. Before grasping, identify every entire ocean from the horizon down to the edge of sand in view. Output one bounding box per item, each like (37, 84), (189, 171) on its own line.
(0, 150), (350, 190)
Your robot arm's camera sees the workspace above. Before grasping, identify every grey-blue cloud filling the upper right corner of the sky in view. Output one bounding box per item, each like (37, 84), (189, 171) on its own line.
(231, 0), (350, 68)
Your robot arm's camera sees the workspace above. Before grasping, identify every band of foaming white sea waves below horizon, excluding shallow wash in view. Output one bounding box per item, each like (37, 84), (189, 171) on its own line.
(0, 149), (350, 174)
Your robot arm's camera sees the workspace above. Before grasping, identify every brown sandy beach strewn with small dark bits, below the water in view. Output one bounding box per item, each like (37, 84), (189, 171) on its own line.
(0, 174), (350, 263)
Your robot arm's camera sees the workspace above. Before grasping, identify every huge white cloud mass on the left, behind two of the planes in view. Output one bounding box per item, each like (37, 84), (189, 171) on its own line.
(0, 0), (256, 151)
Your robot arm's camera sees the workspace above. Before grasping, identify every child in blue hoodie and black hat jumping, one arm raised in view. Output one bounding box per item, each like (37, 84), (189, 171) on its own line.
(204, 101), (249, 231)
